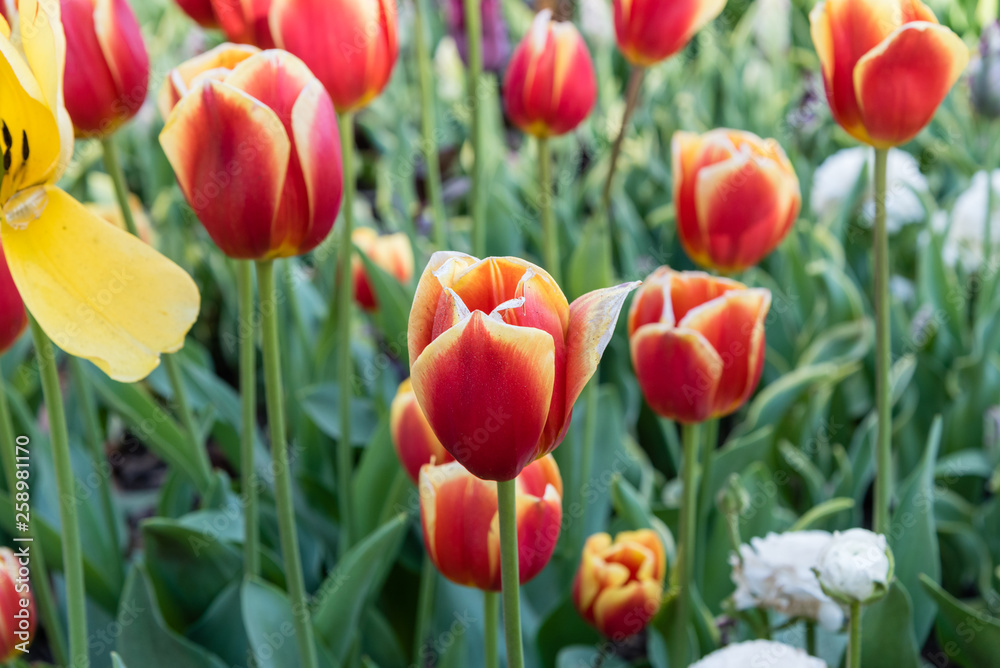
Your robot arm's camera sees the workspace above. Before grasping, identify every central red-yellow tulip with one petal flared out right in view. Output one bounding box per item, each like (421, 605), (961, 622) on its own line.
(408, 252), (638, 480)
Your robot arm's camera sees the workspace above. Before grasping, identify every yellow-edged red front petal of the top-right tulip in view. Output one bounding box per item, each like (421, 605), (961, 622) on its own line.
(853, 21), (969, 148)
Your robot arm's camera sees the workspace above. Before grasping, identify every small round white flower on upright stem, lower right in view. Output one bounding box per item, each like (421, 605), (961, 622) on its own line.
(816, 529), (892, 603)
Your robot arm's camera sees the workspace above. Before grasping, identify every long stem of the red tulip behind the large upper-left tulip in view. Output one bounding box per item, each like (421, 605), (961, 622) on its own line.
(337, 112), (355, 556)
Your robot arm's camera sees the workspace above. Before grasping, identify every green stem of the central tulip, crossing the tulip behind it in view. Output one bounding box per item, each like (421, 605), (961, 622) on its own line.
(497, 480), (524, 668)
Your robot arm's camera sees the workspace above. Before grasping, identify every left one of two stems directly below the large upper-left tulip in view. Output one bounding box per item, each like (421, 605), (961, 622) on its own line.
(236, 260), (260, 577)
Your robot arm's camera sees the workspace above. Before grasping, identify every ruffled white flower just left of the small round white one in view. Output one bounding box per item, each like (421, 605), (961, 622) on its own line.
(729, 531), (844, 631)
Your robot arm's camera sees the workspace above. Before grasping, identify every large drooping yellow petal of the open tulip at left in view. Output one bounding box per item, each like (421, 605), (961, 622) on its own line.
(0, 186), (200, 382)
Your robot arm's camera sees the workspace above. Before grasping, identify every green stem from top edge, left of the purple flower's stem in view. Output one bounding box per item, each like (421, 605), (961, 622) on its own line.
(413, 0), (448, 245)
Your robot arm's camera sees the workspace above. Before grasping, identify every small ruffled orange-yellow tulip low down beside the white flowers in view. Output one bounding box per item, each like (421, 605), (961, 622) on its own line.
(573, 529), (667, 640)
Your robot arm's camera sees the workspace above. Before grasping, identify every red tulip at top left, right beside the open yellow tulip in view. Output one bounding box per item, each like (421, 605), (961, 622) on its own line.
(61, 0), (149, 137)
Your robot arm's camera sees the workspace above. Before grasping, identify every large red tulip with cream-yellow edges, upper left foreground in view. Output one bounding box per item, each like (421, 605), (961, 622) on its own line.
(160, 47), (343, 260)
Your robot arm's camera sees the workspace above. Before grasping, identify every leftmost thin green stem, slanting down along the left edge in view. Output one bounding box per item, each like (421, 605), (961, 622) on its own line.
(0, 370), (67, 665)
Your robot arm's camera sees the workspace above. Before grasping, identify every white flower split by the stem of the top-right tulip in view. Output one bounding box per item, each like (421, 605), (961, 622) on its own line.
(810, 146), (928, 233)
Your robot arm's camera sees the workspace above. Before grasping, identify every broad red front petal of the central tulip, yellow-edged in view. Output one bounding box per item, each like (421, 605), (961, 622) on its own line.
(412, 311), (555, 480)
